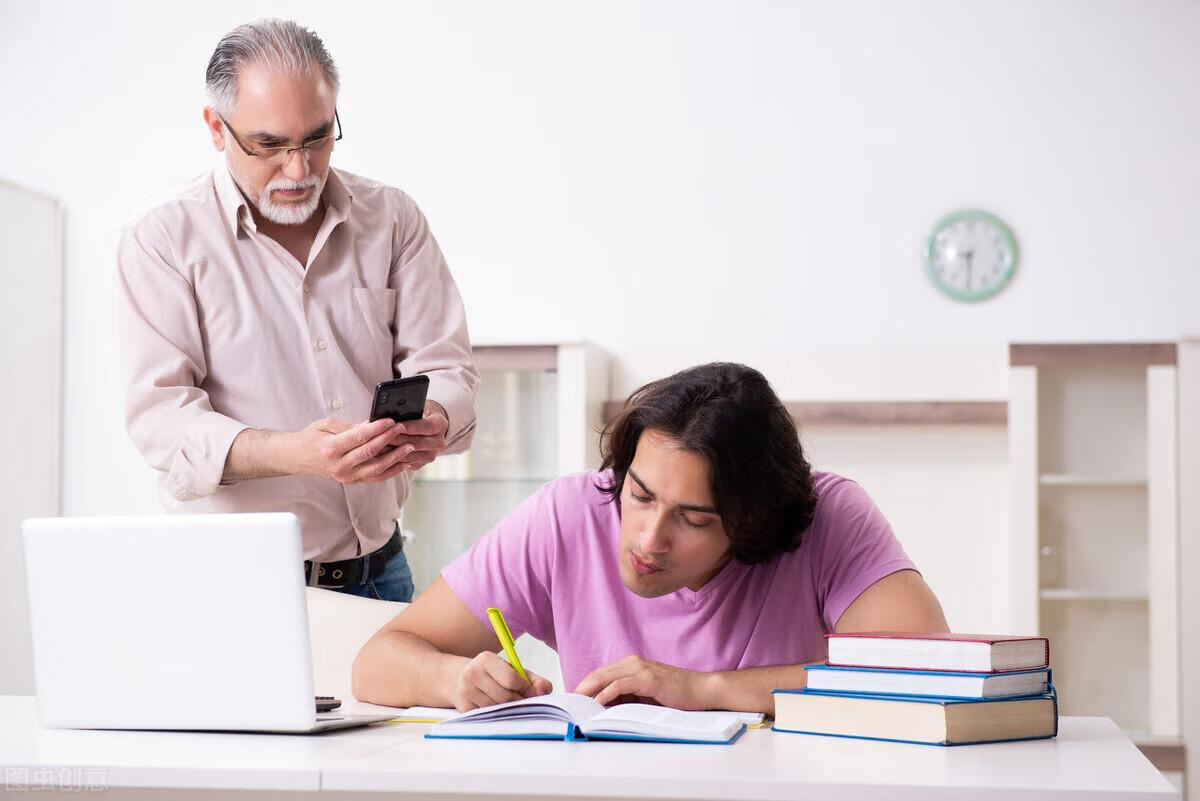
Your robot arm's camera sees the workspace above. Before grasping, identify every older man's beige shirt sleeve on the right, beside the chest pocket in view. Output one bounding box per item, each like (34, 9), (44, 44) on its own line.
(389, 194), (479, 453)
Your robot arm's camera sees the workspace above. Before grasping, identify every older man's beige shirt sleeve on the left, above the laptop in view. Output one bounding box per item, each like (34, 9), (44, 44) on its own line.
(116, 216), (247, 501)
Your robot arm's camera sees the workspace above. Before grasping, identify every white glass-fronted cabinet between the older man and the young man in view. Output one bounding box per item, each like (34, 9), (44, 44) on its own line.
(403, 343), (608, 592)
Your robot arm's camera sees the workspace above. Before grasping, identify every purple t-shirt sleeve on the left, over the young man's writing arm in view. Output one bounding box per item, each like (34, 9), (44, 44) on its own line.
(442, 474), (562, 644)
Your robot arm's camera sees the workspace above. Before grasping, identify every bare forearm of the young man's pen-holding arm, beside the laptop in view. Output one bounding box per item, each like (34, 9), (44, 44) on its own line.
(350, 631), (470, 706)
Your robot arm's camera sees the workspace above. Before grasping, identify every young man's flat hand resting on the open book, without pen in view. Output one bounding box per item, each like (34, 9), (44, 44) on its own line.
(575, 656), (715, 710)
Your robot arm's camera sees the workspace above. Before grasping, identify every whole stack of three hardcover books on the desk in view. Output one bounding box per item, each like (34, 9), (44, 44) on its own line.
(772, 632), (1058, 746)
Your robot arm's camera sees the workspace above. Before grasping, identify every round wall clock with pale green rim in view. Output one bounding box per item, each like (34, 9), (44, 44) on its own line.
(925, 211), (1016, 301)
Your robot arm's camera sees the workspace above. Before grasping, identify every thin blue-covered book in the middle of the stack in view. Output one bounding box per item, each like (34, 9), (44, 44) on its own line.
(805, 664), (1051, 699)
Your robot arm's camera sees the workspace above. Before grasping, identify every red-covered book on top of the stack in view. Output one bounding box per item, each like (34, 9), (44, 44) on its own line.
(826, 632), (1050, 673)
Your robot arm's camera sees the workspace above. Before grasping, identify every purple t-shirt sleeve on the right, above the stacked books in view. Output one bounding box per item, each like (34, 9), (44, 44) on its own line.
(812, 480), (916, 632)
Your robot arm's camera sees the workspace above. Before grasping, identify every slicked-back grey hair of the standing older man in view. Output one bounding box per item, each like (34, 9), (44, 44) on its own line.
(204, 19), (338, 115)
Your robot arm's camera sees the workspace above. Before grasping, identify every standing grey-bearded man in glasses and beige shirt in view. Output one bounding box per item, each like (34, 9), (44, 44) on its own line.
(118, 19), (479, 601)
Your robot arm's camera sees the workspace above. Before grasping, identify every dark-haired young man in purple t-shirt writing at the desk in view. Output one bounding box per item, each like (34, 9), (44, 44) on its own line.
(354, 363), (947, 712)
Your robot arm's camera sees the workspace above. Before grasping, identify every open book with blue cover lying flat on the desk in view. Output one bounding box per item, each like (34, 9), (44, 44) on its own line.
(425, 693), (746, 745)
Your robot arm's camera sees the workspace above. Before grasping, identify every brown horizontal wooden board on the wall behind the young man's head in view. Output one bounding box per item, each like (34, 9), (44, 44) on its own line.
(604, 401), (1008, 426)
